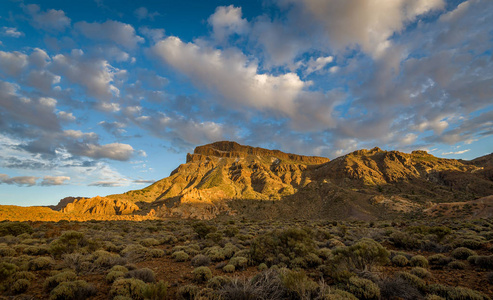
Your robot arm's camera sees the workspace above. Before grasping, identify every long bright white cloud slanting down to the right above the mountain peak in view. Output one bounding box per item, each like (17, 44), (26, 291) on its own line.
(152, 37), (310, 115)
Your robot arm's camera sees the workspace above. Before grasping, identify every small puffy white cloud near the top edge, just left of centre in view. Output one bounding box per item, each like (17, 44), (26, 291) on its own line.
(208, 5), (248, 41)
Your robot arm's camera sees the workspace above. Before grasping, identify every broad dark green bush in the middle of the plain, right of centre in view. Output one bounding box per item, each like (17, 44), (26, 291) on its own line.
(250, 228), (315, 263)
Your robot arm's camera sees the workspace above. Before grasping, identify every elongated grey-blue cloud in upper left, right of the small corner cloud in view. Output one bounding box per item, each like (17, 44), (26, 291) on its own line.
(74, 20), (144, 49)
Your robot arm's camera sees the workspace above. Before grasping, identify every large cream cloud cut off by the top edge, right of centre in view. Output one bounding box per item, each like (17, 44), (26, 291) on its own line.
(292, 0), (445, 58)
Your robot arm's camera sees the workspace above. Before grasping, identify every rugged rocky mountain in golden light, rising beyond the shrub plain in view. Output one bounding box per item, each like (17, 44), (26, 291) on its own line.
(2, 142), (493, 220)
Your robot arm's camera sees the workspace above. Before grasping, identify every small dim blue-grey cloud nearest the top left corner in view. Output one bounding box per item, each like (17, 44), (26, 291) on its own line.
(24, 4), (71, 31)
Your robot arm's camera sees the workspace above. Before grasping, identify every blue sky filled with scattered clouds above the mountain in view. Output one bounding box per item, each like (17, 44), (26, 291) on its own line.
(0, 0), (493, 206)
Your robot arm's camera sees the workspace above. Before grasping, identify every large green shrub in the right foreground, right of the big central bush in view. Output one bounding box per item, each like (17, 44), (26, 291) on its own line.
(332, 238), (390, 271)
